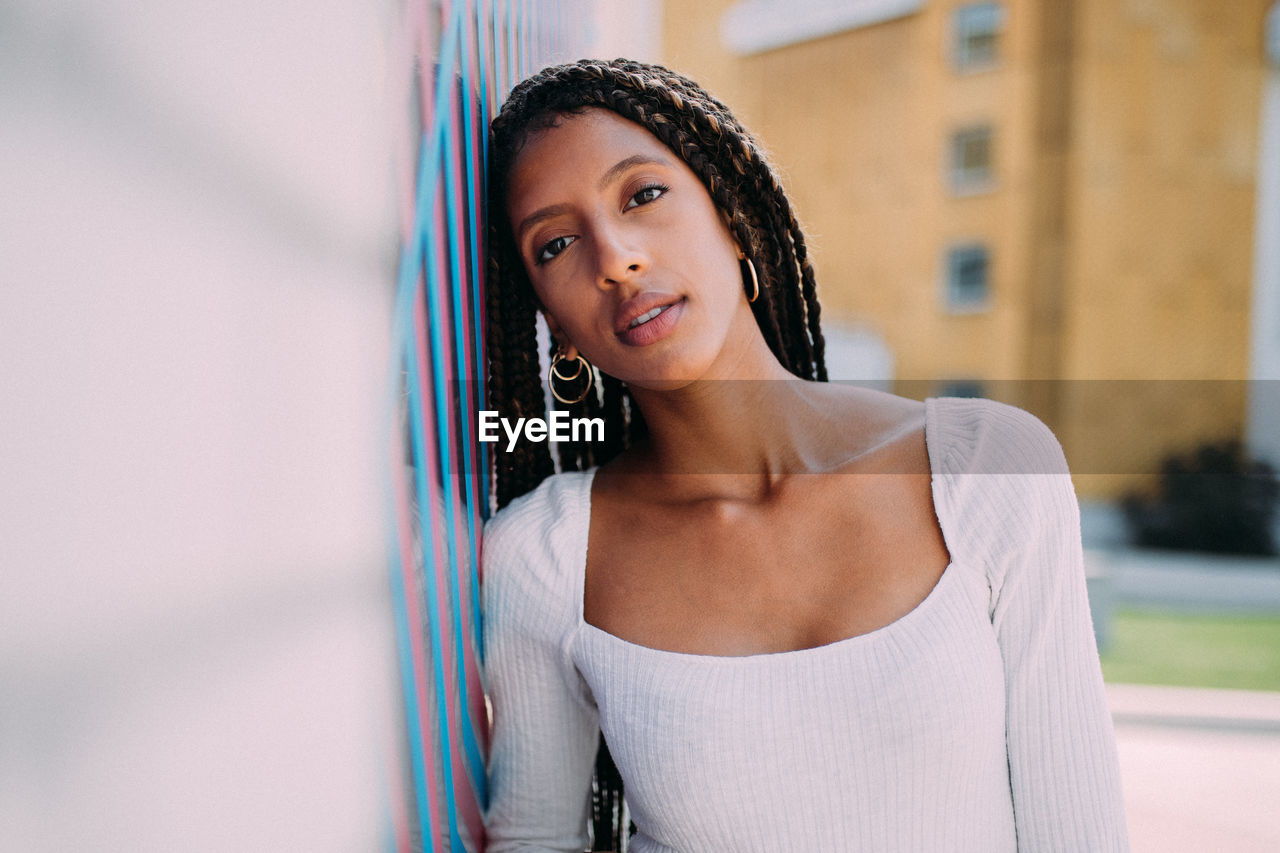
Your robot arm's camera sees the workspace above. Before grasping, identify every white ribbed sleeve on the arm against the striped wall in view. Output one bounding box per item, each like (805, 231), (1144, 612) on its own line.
(481, 481), (599, 853)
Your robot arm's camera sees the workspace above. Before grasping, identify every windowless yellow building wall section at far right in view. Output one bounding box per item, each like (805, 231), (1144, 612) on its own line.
(1062, 0), (1268, 492)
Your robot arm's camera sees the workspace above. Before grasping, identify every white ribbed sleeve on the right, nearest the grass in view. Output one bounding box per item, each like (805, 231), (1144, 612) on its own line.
(942, 401), (1129, 853)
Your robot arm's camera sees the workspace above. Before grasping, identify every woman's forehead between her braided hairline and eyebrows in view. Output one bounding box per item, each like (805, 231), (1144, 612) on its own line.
(507, 108), (678, 211)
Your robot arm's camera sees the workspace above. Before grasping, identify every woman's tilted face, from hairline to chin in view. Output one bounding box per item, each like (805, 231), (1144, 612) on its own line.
(507, 109), (759, 388)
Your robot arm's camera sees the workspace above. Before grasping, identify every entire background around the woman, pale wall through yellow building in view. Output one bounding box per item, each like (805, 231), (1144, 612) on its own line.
(0, 0), (1280, 850)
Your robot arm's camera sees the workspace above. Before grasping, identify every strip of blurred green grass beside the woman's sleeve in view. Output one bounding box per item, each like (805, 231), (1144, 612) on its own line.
(1102, 610), (1280, 690)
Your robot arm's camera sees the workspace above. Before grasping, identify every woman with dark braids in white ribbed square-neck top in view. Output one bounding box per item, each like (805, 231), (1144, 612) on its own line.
(483, 60), (1128, 853)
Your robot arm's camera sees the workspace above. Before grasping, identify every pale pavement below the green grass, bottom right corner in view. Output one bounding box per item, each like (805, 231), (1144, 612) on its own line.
(1107, 685), (1280, 853)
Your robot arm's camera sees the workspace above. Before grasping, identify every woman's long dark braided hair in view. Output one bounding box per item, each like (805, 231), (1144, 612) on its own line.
(485, 59), (827, 850)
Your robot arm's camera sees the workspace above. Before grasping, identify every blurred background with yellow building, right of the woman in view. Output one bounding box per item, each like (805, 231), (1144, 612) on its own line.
(654, 0), (1280, 850)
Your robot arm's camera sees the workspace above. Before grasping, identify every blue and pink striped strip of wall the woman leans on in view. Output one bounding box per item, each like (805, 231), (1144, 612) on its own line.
(389, 0), (591, 852)
